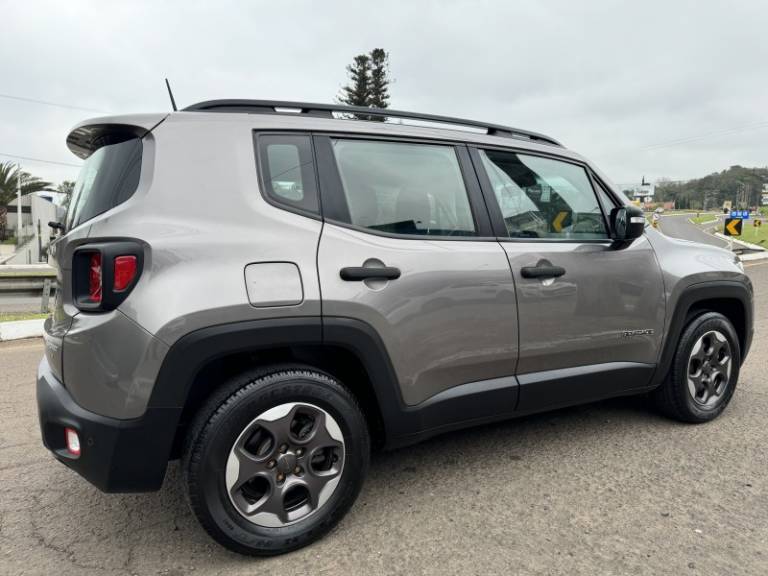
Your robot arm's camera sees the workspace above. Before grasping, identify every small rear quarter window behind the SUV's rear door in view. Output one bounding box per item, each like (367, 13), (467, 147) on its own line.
(257, 134), (320, 213)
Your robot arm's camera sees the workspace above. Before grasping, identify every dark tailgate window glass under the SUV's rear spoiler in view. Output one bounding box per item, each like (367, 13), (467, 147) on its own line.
(66, 138), (142, 230)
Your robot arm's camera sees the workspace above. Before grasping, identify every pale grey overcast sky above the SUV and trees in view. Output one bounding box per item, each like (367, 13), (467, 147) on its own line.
(0, 0), (768, 187)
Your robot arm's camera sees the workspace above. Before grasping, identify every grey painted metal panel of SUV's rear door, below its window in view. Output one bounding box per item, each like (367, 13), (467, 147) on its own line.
(318, 224), (517, 405)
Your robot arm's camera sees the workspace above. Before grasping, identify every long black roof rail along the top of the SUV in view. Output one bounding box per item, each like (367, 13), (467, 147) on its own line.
(182, 100), (562, 146)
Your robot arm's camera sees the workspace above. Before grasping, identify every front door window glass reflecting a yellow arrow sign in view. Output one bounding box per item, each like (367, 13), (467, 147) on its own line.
(480, 150), (608, 240)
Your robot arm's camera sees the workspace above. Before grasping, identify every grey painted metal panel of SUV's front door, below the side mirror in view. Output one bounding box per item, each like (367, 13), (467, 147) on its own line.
(502, 237), (666, 374)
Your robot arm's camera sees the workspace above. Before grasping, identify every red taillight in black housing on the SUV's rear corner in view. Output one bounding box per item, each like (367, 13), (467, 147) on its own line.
(72, 240), (145, 312)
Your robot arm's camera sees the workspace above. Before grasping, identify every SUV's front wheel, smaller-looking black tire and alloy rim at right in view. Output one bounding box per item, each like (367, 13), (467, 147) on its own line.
(653, 312), (741, 424)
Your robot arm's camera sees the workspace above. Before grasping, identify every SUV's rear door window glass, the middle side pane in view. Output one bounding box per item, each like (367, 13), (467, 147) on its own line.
(332, 139), (476, 236)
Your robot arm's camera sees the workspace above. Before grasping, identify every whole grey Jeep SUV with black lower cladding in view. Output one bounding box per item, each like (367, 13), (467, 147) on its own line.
(37, 100), (753, 555)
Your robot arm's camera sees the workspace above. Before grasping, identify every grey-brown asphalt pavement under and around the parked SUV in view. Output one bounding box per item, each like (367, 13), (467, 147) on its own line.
(0, 261), (768, 576)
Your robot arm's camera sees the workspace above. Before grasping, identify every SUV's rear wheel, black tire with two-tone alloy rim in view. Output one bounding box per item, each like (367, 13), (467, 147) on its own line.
(182, 365), (370, 556)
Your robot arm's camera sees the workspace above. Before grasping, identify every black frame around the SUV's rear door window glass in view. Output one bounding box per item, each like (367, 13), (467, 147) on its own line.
(313, 132), (496, 242)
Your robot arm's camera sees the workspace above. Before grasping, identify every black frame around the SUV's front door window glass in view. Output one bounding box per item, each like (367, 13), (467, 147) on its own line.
(467, 144), (614, 245)
